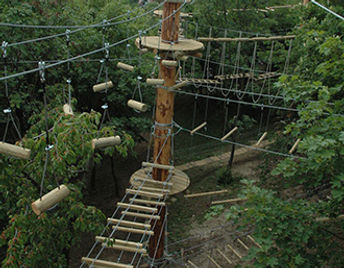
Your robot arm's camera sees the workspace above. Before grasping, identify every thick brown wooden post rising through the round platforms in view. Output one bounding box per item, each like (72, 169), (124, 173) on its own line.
(148, 1), (181, 267)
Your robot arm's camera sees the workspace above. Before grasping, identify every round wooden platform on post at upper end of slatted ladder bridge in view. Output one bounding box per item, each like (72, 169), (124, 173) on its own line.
(129, 168), (190, 195)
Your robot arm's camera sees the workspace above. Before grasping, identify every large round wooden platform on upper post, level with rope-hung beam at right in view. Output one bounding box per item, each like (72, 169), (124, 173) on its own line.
(135, 36), (204, 52)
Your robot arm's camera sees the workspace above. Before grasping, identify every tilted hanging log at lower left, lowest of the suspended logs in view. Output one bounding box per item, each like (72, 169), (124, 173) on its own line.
(31, 184), (70, 215)
